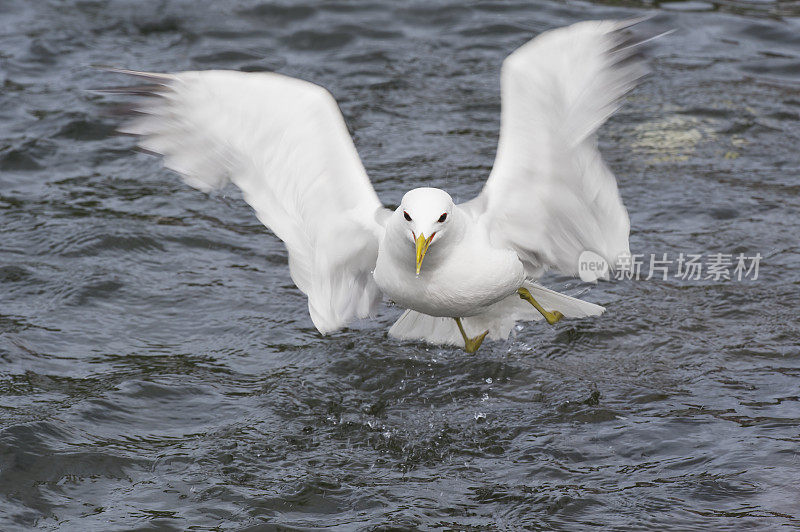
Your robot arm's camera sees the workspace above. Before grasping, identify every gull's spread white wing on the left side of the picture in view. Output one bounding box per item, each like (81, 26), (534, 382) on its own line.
(104, 66), (382, 334)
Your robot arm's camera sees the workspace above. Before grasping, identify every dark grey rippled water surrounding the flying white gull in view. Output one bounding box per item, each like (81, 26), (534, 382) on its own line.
(0, 0), (800, 531)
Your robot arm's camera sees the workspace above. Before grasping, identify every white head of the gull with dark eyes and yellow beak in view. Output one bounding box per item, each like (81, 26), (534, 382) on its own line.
(395, 187), (453, 275)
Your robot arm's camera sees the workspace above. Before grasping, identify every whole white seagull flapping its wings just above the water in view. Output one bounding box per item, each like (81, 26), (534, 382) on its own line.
(101, 20), (646, 353)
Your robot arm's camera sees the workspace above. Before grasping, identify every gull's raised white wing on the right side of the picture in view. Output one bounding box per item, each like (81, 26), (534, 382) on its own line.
(467, 21), (646, 276)
